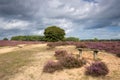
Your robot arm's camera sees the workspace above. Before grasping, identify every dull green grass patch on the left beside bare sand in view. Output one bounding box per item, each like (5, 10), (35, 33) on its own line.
(0, 49), (39, 80)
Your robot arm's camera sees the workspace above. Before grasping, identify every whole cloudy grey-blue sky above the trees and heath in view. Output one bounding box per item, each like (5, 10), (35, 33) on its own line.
(0, 0), (120, 39)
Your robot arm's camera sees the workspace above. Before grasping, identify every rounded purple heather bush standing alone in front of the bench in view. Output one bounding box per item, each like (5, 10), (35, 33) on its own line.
(85, 62), (109, 77)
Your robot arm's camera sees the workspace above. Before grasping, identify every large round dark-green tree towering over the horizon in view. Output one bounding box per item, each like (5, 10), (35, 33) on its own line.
(44, 26), (65, 42)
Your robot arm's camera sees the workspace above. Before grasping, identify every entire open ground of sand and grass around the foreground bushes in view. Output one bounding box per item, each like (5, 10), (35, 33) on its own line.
(0, 41), (120, 80)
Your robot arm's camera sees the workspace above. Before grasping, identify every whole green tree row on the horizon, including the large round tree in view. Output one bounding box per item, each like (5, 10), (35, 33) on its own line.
(11, 26), (79, 42)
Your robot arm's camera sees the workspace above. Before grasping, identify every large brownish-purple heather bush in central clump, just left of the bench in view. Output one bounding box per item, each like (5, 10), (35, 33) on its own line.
(60, 54), (84, 69)
